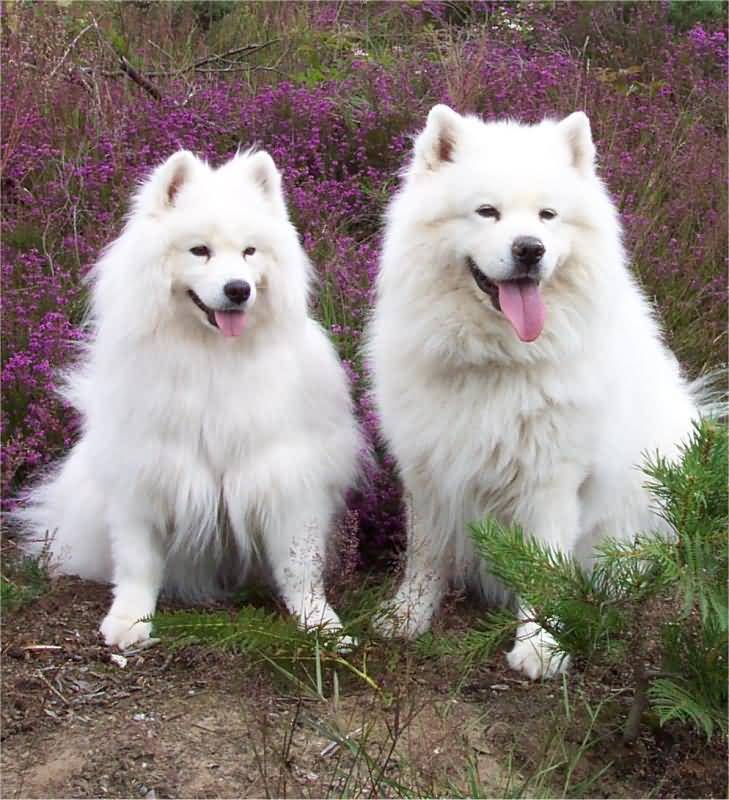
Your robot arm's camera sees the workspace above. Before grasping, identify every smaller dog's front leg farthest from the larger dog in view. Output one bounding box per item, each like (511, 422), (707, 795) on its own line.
(100, 515), (165, 649)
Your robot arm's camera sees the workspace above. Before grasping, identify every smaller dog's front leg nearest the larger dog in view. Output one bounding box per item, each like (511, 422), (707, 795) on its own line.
(264, 498), (341, 630)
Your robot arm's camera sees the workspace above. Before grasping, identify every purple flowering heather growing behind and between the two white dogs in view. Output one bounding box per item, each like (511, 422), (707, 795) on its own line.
(0, 1), (727, 560)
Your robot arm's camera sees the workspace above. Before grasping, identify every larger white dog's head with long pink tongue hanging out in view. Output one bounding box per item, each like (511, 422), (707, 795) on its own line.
(404, 105), (612, 342)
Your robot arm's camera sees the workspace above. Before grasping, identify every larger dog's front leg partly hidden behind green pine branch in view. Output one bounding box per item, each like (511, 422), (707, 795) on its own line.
(506, 476), (579, 680)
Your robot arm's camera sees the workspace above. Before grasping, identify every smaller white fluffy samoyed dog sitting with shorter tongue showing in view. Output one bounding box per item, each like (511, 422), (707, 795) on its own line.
(17, 151), (361, 647)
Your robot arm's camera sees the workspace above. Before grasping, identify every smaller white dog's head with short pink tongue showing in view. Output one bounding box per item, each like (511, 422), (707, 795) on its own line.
(123, 150), (308, 338)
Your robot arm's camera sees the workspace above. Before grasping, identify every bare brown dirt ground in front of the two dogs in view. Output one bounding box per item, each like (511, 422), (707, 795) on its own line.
(0, 578), (726, 798)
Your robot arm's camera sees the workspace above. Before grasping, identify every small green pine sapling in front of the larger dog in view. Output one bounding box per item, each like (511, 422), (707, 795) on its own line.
(473, 421), (729, 738)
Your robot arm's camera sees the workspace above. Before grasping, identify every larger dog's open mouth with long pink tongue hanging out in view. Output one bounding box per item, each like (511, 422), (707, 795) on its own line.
(468, 256), (547, 342)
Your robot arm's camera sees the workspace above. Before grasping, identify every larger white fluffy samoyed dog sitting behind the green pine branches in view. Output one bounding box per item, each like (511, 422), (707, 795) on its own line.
(368, 105), (698, 678)
